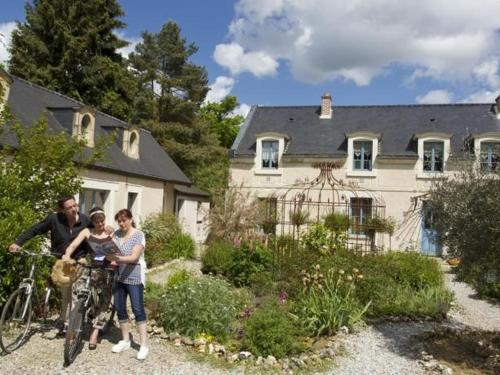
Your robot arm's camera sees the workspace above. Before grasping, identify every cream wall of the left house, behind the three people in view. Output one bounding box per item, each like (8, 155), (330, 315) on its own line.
(77, 169), (168, 225)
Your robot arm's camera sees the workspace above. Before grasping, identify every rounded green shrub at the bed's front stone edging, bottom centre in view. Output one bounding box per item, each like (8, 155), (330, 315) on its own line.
(243, 301), (300, 358)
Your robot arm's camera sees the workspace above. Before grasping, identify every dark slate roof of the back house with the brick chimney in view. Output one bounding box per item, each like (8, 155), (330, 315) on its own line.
(232, 104), (500, 158)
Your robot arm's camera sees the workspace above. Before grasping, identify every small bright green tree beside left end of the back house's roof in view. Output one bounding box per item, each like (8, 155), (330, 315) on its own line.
(200, 96), (243, 149)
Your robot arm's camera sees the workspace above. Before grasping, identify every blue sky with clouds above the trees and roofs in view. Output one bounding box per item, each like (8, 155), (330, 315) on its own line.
(0, 0), (500, 118)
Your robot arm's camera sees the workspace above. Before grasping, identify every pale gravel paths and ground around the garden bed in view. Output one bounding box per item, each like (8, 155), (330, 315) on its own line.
(0, 261), (500, 375)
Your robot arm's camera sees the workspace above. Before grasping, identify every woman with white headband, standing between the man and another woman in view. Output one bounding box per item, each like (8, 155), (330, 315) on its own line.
(62, 207), (115, 350)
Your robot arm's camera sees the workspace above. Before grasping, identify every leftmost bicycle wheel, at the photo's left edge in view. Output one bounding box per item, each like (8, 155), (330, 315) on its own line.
(0, 288), (33, 353)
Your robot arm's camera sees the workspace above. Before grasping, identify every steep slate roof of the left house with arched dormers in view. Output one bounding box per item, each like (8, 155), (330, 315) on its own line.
(1, 76), (191, 185)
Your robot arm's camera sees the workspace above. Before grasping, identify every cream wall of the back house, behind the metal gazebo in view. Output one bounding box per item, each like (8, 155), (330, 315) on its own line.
(231, 153), (453, 254)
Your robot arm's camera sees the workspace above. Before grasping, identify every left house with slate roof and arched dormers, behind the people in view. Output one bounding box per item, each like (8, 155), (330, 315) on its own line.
(0, 68), (207, 241)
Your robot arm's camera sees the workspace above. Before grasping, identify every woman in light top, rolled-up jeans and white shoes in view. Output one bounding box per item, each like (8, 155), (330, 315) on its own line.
(106, 208), (149, 360)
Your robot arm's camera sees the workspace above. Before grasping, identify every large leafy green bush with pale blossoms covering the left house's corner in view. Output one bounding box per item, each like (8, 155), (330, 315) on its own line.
(0, 119), (102, 302)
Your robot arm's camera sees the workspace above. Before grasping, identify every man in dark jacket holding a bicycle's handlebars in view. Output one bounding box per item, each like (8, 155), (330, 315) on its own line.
(9, 196), (90, 334)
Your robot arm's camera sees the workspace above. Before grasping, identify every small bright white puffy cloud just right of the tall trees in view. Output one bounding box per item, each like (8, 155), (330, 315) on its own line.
(214, 43), (278, 77)
